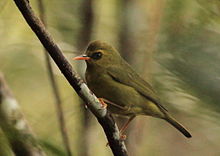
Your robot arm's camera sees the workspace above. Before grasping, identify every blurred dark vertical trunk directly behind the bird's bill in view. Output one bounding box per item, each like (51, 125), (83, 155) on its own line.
(77, 0), (94, 156)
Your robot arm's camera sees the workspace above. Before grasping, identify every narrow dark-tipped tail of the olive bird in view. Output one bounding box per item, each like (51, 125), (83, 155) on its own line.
(165, 114), (192, 138)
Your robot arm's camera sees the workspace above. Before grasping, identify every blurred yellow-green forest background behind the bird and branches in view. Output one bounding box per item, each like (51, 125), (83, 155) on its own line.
(0, 0), (220, 156)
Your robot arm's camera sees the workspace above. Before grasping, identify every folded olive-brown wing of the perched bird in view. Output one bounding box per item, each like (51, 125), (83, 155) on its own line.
(107, 62), (167, 111)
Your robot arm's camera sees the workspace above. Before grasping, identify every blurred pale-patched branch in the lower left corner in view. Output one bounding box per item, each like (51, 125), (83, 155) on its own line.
(0, 73), (45, 156)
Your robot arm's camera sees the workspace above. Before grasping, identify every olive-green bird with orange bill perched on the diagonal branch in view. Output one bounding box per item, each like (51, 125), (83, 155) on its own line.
(74, 41), (191, 138)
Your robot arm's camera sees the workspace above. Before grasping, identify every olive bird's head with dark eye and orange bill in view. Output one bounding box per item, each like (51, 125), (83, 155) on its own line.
(73, 41), (121, 67)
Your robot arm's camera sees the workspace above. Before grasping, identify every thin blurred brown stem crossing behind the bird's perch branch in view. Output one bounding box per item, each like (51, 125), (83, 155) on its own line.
(38, 0), (72, 156)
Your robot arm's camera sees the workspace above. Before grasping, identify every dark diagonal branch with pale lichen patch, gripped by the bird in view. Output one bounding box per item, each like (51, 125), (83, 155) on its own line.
(14, 0), (127, 156)
